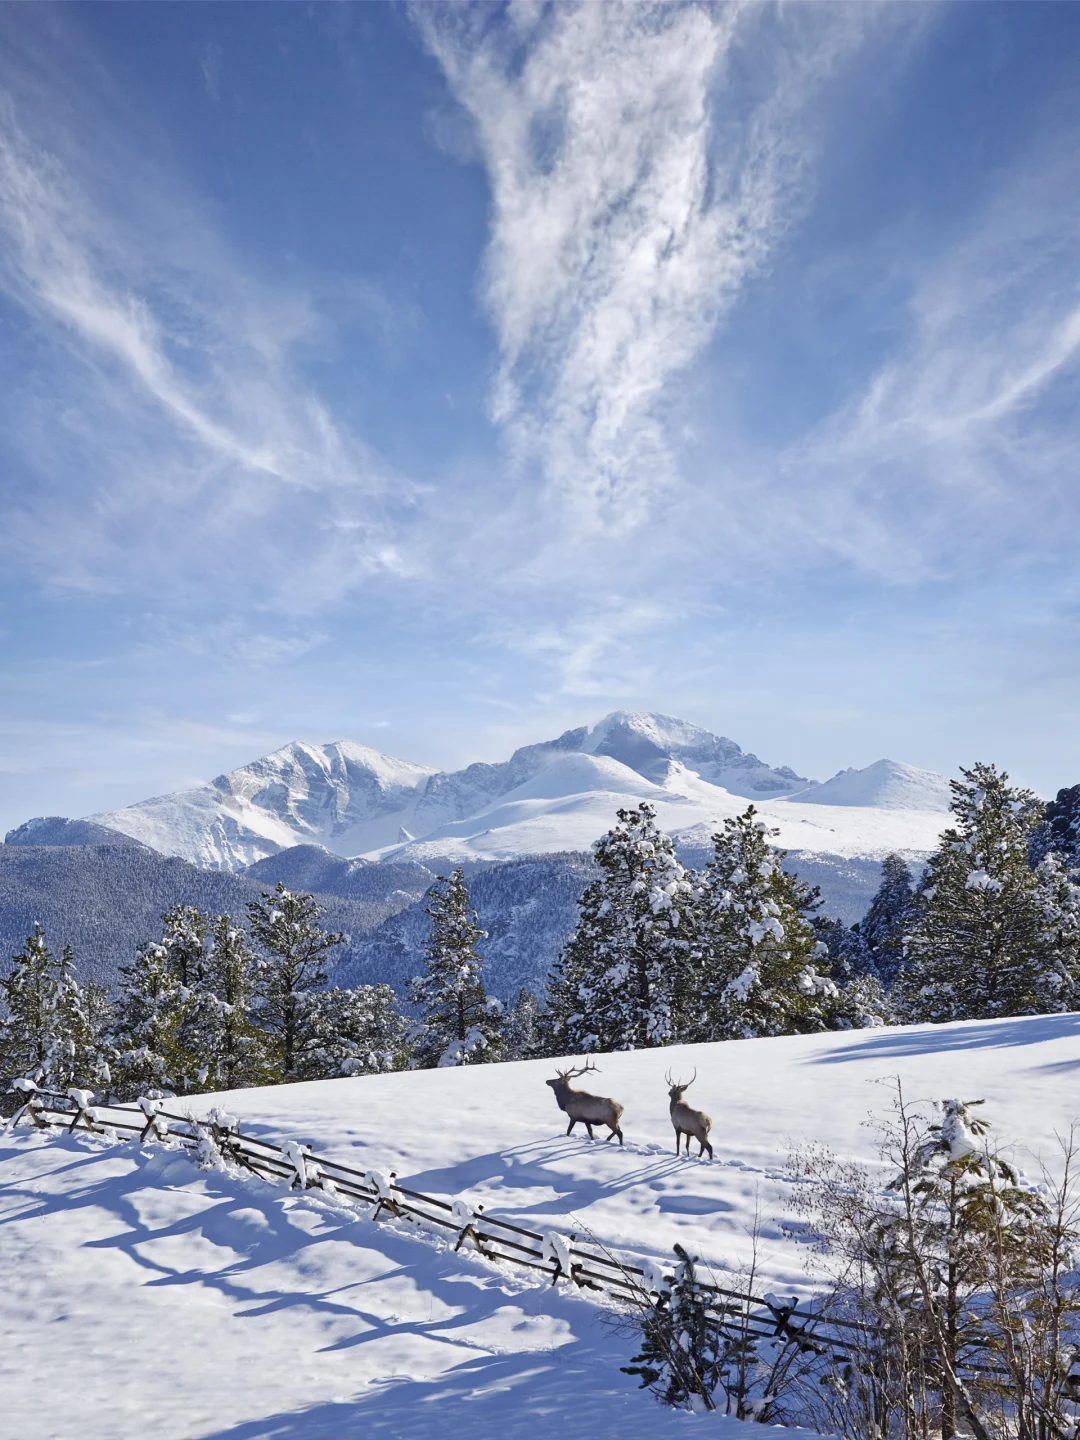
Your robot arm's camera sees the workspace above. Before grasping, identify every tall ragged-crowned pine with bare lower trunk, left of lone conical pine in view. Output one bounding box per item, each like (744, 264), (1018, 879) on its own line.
(248, 881), (346, 1081)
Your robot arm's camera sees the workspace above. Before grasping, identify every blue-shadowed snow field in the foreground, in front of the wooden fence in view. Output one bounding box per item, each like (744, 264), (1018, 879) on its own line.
(0, 1132), (806, 1440)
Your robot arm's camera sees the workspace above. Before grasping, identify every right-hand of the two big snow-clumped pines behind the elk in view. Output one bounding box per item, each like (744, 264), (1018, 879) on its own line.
(691, 805), (838, 1040)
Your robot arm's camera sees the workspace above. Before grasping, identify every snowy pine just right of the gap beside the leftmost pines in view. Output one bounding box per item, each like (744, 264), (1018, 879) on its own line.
(111, 940), (187, 1100)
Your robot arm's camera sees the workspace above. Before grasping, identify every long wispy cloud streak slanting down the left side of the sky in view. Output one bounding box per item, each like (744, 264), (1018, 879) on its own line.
(0, 71), (410, 609)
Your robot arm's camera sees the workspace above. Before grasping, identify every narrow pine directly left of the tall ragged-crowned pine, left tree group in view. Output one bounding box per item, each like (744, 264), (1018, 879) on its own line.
(202, 914), (268, 1090)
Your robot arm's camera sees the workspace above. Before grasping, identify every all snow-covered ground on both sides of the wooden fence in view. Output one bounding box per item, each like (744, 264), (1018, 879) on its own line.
(8, 1015), (1080, 1440)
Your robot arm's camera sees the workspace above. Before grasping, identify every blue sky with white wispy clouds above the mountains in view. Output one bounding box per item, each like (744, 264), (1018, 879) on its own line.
(0, 3), (1080, 825)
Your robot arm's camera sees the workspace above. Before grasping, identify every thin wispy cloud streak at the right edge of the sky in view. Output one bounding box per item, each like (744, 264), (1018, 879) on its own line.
(763, 132), (1080, 582)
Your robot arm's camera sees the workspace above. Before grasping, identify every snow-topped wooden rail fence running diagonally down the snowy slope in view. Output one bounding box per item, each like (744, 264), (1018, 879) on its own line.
(7, 1080), (857, 1359)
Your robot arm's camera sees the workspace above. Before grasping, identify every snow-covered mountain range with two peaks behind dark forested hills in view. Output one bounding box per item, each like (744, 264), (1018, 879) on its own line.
(78, 711), (943, 870)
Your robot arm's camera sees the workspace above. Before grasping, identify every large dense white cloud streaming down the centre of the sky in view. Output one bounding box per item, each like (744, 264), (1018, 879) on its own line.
(413, 3), (874, 533)
